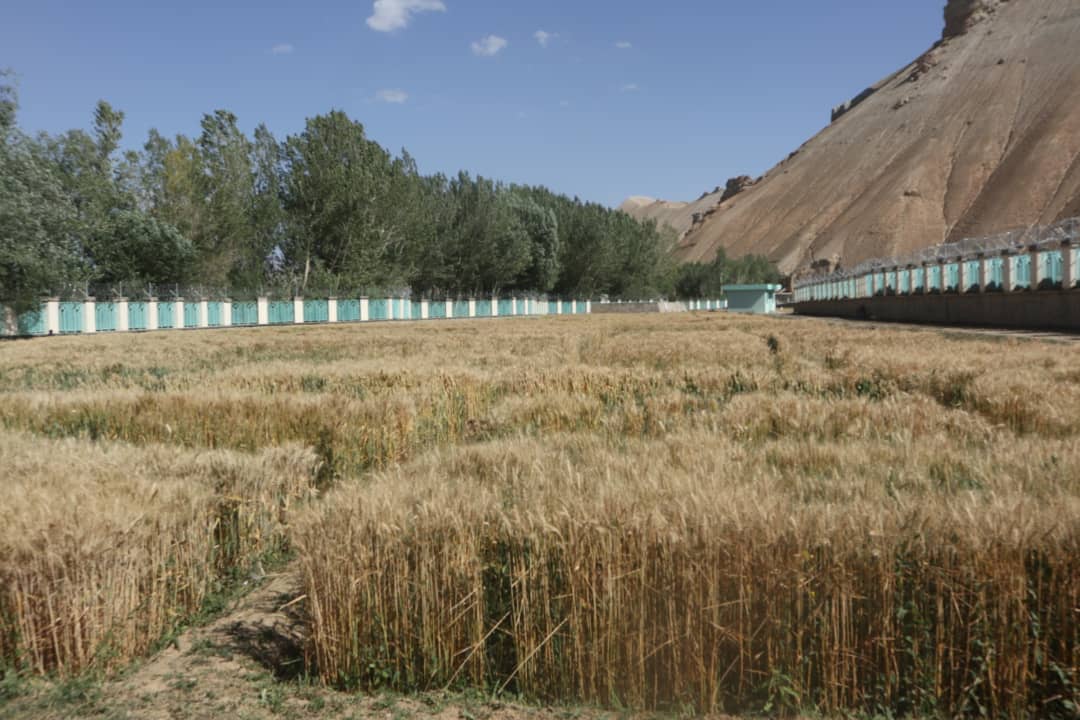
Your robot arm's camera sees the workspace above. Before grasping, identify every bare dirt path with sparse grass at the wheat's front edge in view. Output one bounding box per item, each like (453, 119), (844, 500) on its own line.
(8, 565), (738, 720)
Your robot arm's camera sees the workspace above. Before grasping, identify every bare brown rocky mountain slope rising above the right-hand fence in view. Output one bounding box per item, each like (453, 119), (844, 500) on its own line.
(623, 0), (1080, 273)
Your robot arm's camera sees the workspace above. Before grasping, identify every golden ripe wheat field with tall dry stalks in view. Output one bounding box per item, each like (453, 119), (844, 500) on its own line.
(0, 314), (1080, 717)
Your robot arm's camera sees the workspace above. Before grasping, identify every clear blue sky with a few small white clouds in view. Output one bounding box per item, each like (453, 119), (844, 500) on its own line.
(0, 0), (945, 205)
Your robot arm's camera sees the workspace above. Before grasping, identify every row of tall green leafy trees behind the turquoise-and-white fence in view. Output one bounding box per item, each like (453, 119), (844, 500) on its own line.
(0, 76), (771, 303)
